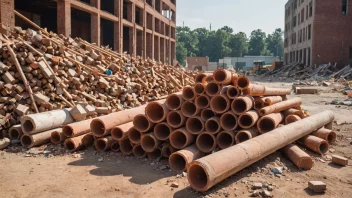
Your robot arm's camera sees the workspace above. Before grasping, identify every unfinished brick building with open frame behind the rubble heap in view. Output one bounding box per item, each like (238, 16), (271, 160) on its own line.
(0, 0), (176, 64)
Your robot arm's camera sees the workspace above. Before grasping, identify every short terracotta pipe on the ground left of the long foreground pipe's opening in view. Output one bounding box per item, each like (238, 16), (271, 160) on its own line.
(169, 144), (204, 171)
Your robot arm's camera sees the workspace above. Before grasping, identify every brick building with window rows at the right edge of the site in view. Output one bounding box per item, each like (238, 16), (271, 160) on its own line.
(284, 0), (352, 66)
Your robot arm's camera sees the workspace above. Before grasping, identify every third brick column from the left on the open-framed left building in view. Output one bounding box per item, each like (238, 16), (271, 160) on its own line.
(90, 0), (100, 46)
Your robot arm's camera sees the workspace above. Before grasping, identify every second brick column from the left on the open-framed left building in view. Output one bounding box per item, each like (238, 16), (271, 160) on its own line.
(57, 0), (71, 36)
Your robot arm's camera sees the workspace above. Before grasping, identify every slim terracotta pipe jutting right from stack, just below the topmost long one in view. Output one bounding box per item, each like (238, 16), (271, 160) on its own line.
(259, 98), (302, 116)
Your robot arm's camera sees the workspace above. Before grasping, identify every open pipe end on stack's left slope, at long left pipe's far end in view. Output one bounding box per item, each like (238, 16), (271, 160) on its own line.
(145, 102), (169, 123)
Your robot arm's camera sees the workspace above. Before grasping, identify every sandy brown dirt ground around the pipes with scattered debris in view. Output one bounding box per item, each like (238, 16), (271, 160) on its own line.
(0, 83), (352, 198)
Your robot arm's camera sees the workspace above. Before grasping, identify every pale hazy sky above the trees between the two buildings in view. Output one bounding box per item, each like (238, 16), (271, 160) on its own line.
(177, 0), (287, 36)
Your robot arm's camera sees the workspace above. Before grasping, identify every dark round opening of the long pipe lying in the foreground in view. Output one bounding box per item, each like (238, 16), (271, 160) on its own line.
(188, 164), (208, 190)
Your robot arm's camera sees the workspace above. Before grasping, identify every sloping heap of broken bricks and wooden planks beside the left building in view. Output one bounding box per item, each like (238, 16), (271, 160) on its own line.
(0, 26), (194, 137)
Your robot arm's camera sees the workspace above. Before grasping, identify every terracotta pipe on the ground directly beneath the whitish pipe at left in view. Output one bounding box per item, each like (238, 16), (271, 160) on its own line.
(21, 128), (62, 148)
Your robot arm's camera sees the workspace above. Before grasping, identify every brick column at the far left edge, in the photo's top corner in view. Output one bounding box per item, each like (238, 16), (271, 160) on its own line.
(0, 0), (15, 26)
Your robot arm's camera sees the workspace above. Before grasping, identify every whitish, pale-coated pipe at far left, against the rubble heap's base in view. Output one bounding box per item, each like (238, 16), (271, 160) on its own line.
(21, 109), (74, 134)
